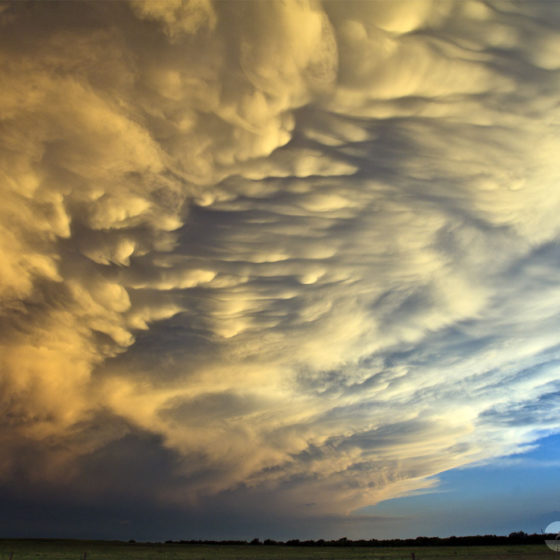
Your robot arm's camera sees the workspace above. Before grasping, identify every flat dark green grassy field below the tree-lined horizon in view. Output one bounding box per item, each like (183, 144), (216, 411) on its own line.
(0, 540), (560, 560)
